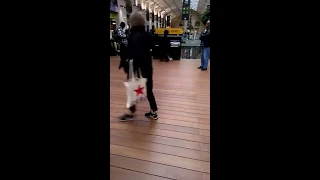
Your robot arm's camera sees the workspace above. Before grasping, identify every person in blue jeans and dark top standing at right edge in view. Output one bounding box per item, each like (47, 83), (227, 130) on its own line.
(198, 21), (210, 71)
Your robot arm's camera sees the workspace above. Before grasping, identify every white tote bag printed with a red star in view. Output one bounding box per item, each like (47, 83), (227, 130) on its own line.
(124, 60), (147, 108)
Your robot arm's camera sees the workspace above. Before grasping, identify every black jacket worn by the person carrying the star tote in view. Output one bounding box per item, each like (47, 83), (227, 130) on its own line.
(119, 26), (153, 77)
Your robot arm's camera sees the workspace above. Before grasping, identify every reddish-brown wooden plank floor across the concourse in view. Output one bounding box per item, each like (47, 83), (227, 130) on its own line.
(110, 57), (210, 180)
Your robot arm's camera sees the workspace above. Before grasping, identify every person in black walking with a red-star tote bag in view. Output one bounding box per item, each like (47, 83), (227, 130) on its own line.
(119, 12), (158, 121)
